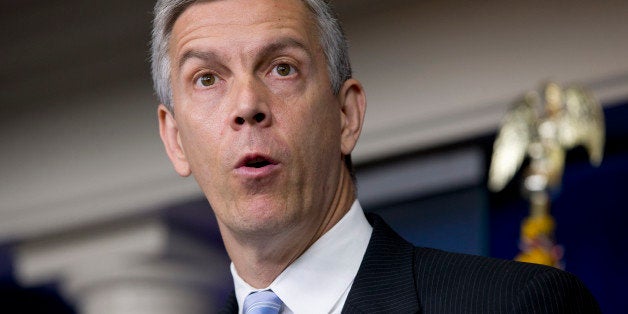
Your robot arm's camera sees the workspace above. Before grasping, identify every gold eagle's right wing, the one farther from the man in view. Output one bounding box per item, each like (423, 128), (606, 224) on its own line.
(558, 87), (605, 166)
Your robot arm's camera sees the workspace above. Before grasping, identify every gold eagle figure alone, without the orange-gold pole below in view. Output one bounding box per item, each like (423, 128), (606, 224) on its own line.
(489, 82), (605, 192)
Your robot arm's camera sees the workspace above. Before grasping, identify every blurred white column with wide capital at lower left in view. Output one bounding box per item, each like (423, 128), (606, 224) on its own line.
(15, 218), (230, 314)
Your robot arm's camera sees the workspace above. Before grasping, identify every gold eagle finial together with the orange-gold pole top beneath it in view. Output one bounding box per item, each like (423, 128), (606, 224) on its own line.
(488, 82), (605, 268)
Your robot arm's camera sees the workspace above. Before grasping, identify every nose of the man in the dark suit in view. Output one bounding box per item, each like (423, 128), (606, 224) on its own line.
(231, 78), (272, 130)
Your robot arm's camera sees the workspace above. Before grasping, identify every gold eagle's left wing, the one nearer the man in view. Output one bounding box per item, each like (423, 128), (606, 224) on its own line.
(488, 93), (539, 192)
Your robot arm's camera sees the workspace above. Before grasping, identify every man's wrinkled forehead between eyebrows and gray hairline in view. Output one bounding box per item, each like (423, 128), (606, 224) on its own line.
(170, 0), (318, 55)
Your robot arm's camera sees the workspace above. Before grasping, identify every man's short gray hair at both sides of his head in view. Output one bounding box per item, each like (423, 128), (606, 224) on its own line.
(151, 0), (351, 113)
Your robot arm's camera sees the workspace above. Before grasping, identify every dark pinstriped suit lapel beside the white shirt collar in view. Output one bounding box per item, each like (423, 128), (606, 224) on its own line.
(342, 214), (419, 313)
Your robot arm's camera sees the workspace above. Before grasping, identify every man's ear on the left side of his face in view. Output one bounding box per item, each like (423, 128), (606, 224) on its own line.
(157, 104), (191, 177)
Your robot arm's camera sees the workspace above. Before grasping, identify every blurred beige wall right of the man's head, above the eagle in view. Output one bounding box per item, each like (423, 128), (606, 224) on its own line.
(344, 0), (628, 161)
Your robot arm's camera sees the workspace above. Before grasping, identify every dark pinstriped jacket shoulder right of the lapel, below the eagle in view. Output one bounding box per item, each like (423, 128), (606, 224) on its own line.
(414, 247), (600, 313)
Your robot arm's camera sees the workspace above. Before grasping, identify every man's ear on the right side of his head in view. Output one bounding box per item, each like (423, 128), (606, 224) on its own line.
(338, 79), (366, 155)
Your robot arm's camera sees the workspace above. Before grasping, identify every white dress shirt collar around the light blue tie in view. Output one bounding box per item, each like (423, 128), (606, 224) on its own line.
(231, 200), (373, 314)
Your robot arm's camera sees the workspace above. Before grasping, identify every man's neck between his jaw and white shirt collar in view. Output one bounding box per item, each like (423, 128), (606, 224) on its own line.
(221, 167), (355, 289)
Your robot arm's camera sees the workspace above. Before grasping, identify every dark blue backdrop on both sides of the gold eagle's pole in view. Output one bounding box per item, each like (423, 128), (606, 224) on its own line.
(490, 104), (628, 313)
